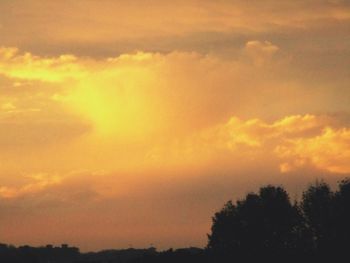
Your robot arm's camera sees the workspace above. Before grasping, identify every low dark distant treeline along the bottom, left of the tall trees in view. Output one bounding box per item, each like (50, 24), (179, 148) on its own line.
(0, 244), (205, 263)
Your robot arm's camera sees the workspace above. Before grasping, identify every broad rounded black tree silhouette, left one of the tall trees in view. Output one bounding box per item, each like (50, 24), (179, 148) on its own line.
(208, 186), (300, 259)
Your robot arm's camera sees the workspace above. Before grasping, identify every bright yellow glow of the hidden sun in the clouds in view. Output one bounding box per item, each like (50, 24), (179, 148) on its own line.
(67, 67), (154, 139)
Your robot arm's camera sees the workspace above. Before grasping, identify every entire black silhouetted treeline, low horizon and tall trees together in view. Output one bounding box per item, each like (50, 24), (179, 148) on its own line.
(0, 179), (350, 263)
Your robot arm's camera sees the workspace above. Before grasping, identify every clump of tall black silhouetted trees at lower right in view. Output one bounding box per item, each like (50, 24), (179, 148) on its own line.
(207, 180), (350, 262)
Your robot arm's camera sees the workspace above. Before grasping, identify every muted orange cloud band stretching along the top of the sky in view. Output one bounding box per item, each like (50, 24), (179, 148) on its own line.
(0, 0), (350, 49)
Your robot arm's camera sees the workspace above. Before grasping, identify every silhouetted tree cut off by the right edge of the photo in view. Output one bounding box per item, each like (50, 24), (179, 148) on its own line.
(300, 179), (350, 260)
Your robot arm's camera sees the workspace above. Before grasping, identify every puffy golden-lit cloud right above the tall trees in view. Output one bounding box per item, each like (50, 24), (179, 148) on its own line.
(219, 115), (350, 174)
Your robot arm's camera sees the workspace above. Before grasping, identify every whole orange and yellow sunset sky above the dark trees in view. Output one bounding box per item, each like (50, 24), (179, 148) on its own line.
(0, 0), (350, 251)
